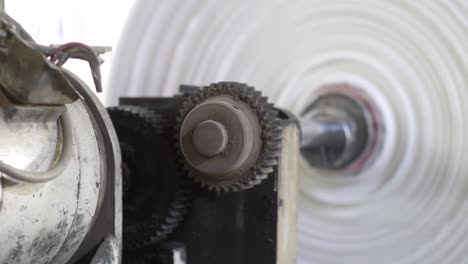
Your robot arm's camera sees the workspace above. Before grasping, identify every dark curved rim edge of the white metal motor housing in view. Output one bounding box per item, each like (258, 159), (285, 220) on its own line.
(65, 71), (122, 264)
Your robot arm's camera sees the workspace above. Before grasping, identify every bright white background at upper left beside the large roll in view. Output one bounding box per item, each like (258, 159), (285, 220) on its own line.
(5, 0), (135, 101)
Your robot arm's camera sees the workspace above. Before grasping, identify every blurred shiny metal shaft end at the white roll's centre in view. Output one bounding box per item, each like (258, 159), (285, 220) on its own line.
(300, 94), (370, 169)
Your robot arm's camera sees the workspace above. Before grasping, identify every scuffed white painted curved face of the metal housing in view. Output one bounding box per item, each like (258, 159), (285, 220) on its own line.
(0, 101), (101, 263)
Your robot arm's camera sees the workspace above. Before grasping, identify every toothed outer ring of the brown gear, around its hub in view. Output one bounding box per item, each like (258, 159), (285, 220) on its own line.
(175, 82), (282, 192)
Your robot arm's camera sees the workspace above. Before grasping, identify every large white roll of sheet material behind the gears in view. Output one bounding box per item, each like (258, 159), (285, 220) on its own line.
(105, 0), (468, 264)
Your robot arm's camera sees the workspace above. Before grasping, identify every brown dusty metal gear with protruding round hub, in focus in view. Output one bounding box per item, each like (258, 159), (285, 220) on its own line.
(176, 82), (281, 191)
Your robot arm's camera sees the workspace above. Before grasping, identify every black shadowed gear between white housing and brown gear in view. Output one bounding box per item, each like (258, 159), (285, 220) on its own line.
(108, 106), (191, 250)
